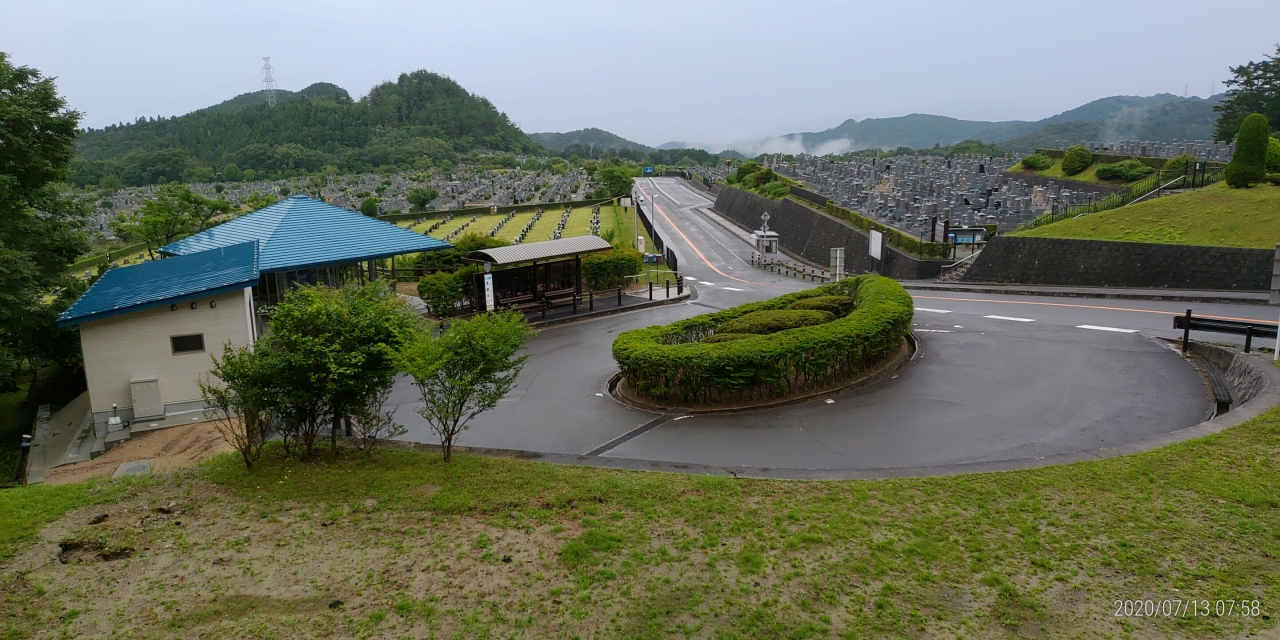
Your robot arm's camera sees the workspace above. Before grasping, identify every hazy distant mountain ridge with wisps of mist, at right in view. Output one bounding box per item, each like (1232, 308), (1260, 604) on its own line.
(773, 93), (1220, 152)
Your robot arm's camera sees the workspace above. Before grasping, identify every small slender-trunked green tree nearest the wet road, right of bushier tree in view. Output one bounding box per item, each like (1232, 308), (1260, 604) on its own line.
(402, 311), (534, 462)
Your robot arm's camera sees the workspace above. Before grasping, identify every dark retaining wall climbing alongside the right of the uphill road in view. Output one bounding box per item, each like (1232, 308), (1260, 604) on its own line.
(716, 187), (947, 280)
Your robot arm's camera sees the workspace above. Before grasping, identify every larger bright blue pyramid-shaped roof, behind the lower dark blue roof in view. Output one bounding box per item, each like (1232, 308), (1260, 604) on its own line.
(160, 195), (451, 273)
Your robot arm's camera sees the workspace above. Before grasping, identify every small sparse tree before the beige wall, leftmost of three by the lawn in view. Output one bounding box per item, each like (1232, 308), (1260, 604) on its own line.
(200, 344), (280, 468)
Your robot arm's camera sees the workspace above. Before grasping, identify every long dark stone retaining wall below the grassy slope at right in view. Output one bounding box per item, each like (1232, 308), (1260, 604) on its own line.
(963, 236), (1275, 291)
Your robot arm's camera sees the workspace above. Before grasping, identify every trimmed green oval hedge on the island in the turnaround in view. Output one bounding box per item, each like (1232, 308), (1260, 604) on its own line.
(613, 275), (913, 403)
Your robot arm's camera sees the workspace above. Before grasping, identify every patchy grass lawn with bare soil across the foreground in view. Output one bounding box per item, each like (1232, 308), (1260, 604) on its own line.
(0, 401), (1280, 639)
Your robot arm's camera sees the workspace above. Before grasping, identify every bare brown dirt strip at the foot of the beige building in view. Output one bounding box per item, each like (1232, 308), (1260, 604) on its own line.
(45, 422), (232, 484)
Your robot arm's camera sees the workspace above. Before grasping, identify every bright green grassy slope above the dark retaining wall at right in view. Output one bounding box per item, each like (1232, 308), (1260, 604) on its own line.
(1015, 182), (1280, 248)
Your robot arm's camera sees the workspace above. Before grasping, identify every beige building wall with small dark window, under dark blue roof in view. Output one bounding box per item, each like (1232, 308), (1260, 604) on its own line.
(79, 291), (252, 420)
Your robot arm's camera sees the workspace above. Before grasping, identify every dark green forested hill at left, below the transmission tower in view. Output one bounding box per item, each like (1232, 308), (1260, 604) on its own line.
(73, 70), (539, 186)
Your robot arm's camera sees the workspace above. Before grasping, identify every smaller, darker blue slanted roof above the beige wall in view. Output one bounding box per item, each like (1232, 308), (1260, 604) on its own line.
(58, 242), (259, 326)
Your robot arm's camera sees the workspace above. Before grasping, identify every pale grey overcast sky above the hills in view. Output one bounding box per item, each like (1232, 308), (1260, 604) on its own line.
(0, 0), (1280, 145)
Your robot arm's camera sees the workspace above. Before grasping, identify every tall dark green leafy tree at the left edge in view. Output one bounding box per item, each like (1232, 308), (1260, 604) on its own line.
(0, 52), (88, 384)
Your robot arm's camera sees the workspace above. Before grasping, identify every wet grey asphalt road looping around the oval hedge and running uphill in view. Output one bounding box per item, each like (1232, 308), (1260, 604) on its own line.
(378, 178), (1275, 477)
